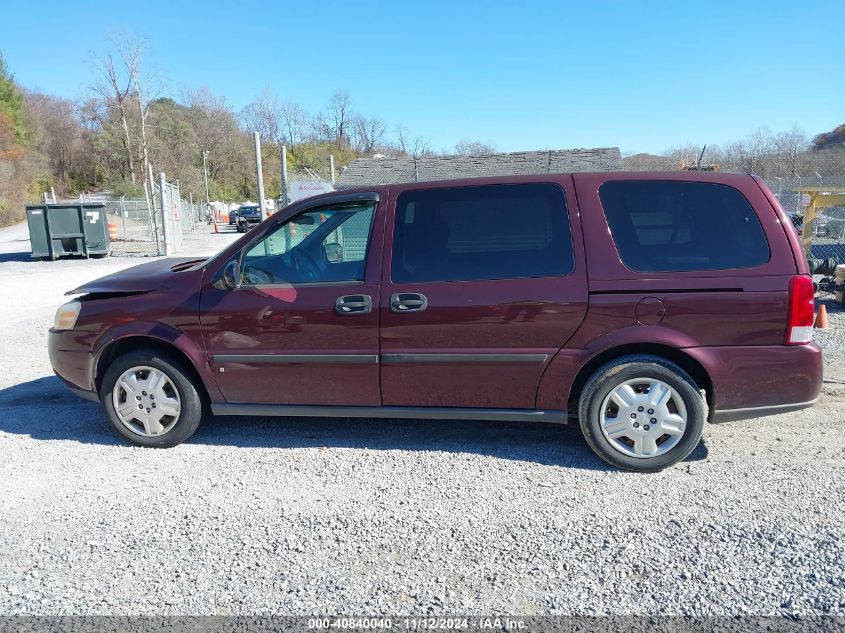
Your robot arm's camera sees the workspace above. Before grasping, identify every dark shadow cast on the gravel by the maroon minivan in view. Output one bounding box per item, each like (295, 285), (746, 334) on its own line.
(0, 376), (708, 470)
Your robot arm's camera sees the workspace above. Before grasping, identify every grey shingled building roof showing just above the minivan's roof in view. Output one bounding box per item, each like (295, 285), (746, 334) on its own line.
(335, 147), (622, 189)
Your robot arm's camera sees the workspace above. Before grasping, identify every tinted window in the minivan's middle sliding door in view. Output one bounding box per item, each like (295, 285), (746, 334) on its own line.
(391, 183), (575, 283)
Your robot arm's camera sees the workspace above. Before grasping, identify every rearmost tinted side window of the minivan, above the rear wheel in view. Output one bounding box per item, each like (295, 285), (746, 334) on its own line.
(599, 180), (769, 272)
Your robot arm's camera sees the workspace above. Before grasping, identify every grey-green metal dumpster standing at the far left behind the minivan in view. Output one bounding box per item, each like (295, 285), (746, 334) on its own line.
(26, 202), (109, 259)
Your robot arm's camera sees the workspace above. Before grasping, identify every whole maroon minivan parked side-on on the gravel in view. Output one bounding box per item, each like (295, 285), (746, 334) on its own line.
(49, 172), (822, 471)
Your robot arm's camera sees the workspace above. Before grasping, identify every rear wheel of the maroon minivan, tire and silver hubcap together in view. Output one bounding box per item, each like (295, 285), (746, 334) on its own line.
(578, 356), (707, 472)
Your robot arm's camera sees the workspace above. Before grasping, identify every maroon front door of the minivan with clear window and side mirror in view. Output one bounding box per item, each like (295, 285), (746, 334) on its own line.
(200, 194), (382, 406)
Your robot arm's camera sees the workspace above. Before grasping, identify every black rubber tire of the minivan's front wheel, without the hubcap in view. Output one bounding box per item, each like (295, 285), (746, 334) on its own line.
(100, 348), (205, 448)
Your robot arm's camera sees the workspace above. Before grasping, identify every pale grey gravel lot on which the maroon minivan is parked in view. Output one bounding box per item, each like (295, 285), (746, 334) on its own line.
(0, 220), (845, 615)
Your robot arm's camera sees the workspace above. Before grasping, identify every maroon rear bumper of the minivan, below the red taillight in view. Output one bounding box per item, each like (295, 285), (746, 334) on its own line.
(684, 343), (823, 422)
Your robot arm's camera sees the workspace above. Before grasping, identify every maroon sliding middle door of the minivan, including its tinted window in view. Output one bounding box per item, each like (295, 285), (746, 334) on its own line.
(381, 176), (587, 409)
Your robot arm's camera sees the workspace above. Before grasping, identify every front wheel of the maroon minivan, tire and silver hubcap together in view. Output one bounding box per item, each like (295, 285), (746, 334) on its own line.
(100, 350), (203, 448)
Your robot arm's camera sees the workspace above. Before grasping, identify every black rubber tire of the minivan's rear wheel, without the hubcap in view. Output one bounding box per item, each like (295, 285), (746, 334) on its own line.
(578, 355), (707, 473)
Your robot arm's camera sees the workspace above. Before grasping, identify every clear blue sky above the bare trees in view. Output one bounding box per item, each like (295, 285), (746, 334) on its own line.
(0, 0), (845, 152)
